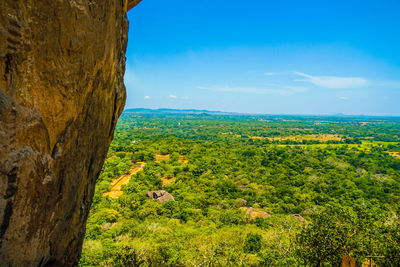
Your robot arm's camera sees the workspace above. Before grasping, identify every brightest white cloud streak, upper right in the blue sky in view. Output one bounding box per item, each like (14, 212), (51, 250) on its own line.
(293, 71), (370, 89)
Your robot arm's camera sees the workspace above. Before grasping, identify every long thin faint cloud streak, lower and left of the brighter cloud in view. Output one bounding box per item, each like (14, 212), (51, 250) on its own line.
(197, 86), (307, 96)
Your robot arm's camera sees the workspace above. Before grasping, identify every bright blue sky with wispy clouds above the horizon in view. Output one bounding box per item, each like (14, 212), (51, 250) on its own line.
(125, 0), (400, 116)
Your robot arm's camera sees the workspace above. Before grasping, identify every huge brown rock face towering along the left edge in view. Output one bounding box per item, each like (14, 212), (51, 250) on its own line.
(0, 0), (138, 266)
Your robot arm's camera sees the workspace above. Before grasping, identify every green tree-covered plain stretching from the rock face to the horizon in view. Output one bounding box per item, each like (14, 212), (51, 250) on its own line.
(80, 112), (400, 266)
